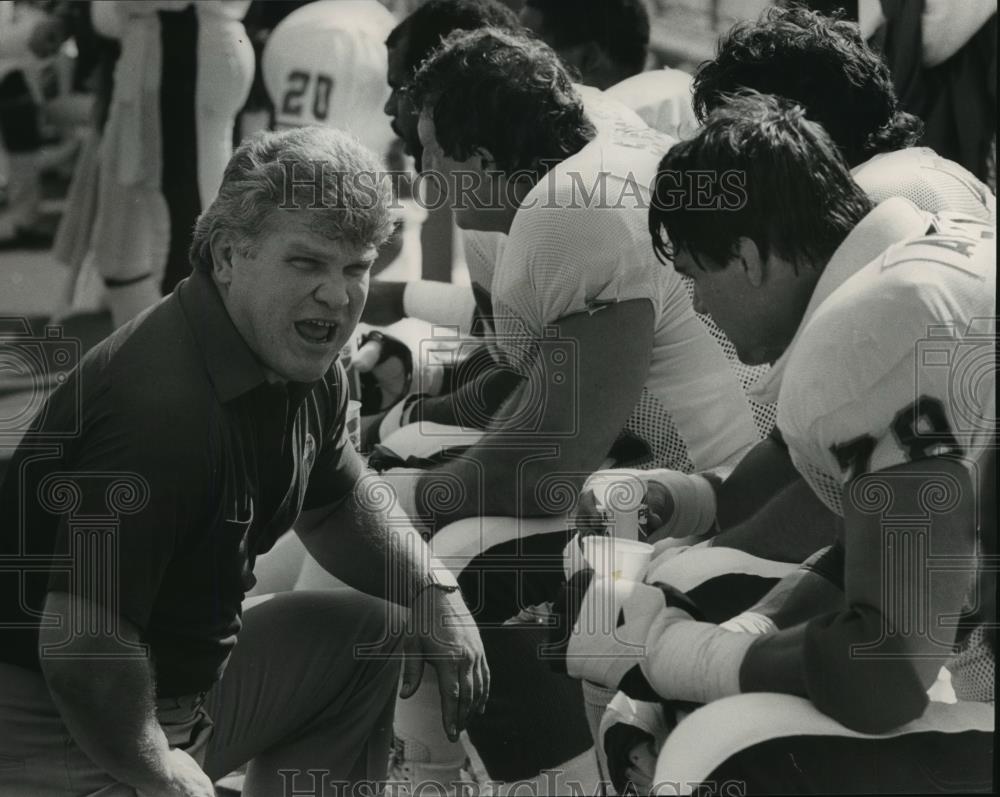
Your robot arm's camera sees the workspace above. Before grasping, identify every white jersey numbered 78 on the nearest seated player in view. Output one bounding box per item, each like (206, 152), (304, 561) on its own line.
(778, 199), (996, 513)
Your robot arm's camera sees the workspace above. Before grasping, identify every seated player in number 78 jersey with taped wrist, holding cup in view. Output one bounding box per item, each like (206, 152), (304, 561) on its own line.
(557, 94), (996, 793)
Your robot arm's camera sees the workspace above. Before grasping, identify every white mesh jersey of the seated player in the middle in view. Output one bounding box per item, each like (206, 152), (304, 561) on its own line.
(491, 126), (759, 472)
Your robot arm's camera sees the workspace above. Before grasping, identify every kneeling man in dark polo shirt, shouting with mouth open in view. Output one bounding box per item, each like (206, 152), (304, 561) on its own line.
(0, 128), (489, 797)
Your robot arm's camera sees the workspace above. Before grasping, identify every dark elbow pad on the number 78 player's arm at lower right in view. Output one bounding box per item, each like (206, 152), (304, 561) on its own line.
(803, 606), (928, 733)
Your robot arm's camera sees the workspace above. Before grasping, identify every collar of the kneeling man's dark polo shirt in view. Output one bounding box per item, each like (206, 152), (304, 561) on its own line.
(176, 271), (267, 404)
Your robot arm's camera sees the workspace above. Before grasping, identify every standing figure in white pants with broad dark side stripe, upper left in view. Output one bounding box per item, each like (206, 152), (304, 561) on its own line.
(59, 0), (254, 327)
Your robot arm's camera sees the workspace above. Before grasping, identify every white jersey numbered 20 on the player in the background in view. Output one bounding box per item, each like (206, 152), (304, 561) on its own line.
(261, 0), (396, 155)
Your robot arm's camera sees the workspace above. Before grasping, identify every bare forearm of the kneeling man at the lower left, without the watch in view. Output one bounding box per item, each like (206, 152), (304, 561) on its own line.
(39, 593), (170, 792)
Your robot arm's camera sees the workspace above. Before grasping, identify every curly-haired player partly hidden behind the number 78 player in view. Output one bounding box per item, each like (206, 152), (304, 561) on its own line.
(694, 6), (996, 221)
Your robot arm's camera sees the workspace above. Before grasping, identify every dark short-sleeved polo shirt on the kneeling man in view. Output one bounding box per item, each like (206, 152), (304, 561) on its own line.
(0, 274), (363, 697)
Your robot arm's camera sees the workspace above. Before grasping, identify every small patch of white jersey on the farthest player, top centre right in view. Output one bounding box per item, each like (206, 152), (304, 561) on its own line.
(604, 67), (700, 141)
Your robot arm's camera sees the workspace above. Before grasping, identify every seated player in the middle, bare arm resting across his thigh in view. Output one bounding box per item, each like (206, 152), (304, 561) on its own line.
(364, 30), (759, 780)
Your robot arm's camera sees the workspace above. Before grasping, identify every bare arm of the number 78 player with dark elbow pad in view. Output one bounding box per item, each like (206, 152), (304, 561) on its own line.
(740, 457), (976, 732)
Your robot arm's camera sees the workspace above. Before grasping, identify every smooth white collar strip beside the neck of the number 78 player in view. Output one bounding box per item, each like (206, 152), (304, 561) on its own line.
(750, 197), (929, 404)
